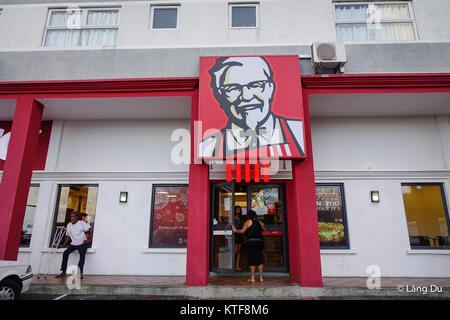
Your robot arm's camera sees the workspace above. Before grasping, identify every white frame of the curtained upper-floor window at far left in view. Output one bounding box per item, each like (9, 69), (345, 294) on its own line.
(41, 7), (121, 49)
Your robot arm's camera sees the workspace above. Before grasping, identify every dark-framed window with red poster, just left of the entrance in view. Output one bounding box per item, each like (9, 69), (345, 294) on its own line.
(150, 185), (188, 247)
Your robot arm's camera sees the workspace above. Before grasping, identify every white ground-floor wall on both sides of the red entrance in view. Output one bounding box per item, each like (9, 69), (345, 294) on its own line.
(19, 116), (450, 277)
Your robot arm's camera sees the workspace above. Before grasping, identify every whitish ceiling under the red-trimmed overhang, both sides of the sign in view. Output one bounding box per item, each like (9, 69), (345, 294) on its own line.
(0, 92), (450, 121)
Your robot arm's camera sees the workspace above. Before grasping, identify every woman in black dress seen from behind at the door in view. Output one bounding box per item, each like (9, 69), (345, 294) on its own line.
(232, 210), (266, 282)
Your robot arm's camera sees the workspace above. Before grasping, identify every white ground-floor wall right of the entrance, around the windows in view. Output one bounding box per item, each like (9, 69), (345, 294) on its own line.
(311, 116), (450, 277)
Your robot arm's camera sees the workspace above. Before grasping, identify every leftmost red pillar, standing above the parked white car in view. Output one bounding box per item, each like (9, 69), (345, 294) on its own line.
(0, 96), (44, 260)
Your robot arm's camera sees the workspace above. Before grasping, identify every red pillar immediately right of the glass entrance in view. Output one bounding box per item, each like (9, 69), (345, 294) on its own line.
(286, 93), (322, 287)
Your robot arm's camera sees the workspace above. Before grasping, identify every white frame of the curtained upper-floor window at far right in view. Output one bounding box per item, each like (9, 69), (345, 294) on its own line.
(333, 1), (420, 43)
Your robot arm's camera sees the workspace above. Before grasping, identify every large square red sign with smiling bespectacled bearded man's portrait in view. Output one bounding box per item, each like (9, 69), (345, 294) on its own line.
(198, 56), (305, 159)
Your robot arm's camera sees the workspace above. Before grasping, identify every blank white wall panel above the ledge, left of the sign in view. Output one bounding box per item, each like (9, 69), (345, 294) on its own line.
(51, 120), (190, 172)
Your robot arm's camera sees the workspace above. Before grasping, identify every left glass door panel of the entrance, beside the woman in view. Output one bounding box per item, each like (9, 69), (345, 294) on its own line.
(212, 182), (235, 273)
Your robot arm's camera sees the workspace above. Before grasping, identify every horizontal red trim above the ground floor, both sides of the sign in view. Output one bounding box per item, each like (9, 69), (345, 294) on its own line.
(0, 73), (450, 99)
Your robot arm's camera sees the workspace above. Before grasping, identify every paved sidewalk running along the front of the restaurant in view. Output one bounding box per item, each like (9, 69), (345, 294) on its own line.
(28, 275), (450, 299)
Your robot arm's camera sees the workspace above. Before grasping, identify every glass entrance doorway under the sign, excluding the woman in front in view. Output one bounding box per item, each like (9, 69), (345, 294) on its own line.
(210, 182), (288, 274)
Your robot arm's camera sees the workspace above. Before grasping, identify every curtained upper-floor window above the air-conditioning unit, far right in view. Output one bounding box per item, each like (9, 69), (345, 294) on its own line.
(334, 2), (416, 41)
